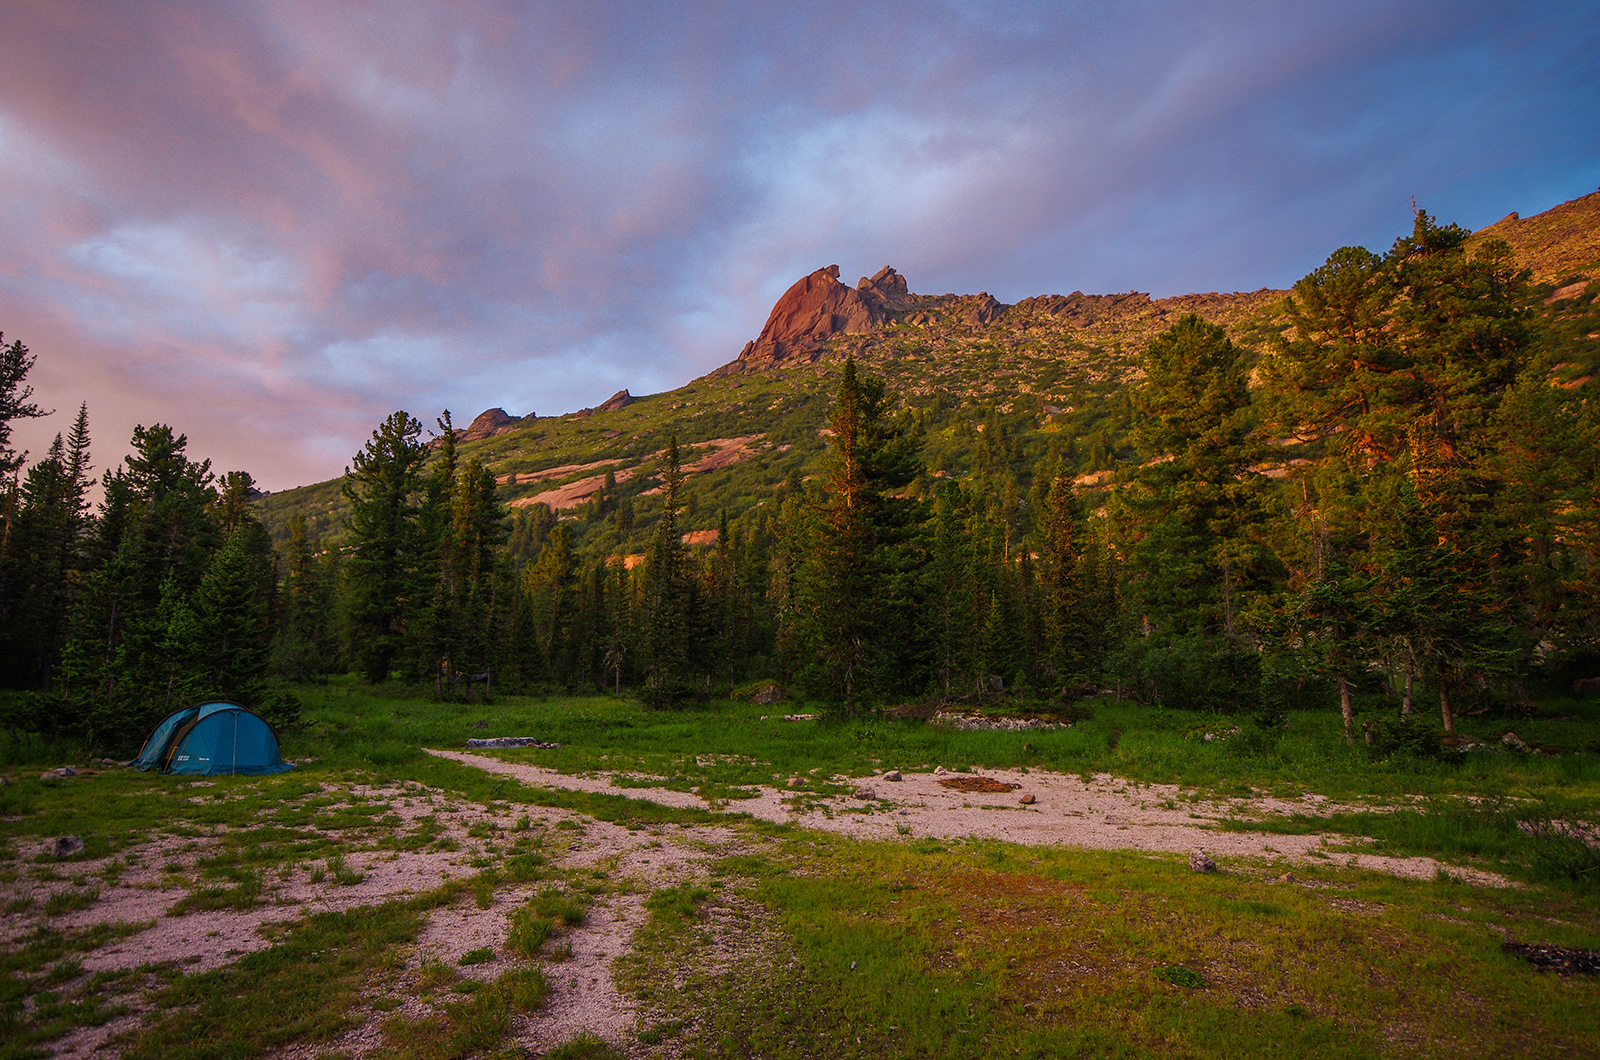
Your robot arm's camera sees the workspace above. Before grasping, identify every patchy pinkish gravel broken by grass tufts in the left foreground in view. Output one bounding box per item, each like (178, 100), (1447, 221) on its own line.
(0, 785), (742, 1058)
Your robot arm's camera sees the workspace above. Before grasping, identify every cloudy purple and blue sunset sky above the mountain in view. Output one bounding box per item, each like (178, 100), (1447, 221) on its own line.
(0, 0), (1600, 490)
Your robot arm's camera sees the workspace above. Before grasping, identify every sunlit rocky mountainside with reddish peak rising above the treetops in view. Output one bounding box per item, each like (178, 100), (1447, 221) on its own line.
(261, 194), (1600, 551)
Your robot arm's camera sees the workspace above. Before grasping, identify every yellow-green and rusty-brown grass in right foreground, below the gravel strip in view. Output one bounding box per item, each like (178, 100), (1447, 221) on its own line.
(626, 833), (1600, 1057)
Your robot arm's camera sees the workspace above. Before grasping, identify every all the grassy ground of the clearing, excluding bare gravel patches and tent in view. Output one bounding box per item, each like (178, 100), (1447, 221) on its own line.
(0, 682), (1600, 1058)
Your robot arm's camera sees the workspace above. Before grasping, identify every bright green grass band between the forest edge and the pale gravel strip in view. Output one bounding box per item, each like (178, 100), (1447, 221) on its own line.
(291, 685), (1600, 809)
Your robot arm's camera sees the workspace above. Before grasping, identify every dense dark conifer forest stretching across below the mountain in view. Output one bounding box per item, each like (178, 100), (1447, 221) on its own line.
(0, 211), (1600, 749)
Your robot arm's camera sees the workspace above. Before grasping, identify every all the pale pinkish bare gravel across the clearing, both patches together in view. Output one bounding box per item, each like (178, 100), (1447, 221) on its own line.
(0, 749), (1509, 1060)
